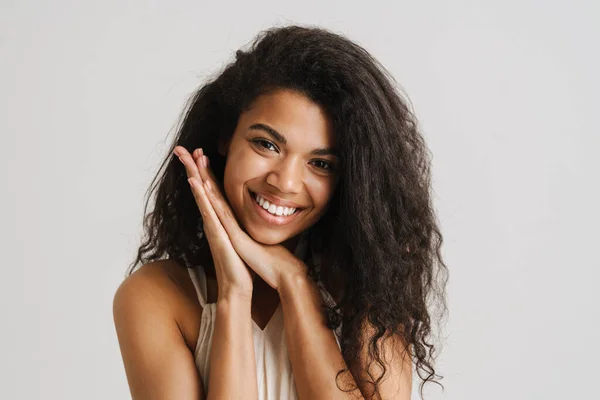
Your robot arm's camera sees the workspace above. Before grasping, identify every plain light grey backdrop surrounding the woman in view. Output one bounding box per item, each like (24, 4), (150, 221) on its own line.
(0, 0), (600, 400)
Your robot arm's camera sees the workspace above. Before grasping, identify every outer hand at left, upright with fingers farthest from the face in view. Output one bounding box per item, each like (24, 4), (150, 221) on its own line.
(173, 146), (254, 299)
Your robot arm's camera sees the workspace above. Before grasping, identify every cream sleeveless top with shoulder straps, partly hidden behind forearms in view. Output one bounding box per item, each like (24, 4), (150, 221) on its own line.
(188, 236), (341, 400)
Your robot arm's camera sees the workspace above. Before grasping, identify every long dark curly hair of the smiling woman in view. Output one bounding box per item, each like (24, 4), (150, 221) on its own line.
(129, 26), (448, 397)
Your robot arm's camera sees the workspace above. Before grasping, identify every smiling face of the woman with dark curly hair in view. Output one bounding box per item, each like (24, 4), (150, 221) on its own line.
(221, 90), (339, 245)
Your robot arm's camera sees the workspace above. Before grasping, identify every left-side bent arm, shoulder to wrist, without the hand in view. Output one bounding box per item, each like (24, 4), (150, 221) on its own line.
(113, 266), (258, 400)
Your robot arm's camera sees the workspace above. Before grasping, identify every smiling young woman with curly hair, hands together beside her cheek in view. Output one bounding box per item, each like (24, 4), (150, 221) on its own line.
(114, 26), (447, 400)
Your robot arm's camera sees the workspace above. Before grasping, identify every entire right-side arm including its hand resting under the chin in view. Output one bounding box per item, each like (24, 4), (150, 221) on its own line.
(176, 148), (412, 400)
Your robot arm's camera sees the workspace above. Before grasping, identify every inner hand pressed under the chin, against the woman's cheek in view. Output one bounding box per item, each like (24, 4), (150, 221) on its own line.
(193, 150), (307, 291)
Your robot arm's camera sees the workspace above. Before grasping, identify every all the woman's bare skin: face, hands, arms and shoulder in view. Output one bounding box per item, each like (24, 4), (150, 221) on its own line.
(114, 91), (410, 399)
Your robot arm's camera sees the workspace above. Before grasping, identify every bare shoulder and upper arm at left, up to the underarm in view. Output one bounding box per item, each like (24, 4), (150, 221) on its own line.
(113, 260), (205, 399)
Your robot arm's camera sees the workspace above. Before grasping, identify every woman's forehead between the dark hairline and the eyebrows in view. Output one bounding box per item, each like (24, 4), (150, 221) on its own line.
(238, 89), (335, 149)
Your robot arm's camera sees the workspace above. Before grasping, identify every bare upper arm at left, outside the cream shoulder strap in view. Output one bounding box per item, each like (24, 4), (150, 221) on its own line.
(113, 266), (206, 400)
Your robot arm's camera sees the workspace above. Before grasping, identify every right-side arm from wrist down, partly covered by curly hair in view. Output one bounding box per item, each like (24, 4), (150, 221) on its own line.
(279, 274), (412, 400)
